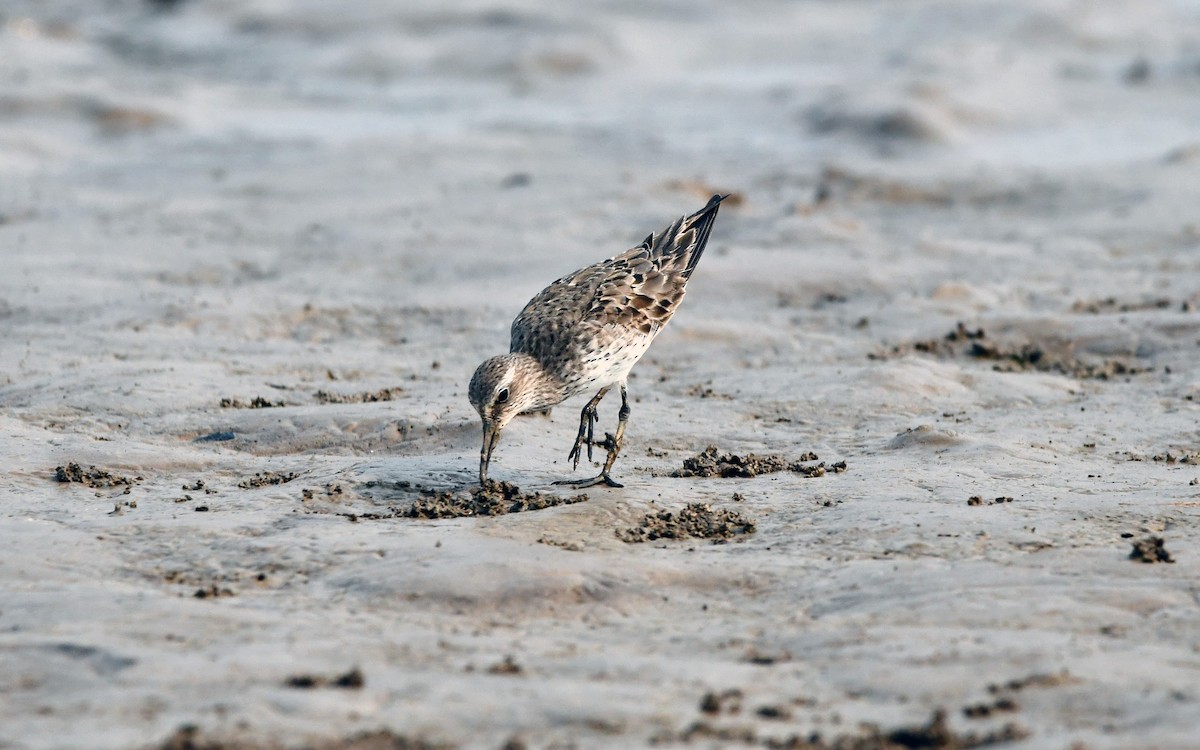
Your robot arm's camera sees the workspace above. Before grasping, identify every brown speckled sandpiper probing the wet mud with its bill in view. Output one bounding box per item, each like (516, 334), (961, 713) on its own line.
(468, 196), (727, 487)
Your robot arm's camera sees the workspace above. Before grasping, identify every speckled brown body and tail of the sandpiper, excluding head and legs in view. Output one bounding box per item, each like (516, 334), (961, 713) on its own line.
(510, 196), (722, 390)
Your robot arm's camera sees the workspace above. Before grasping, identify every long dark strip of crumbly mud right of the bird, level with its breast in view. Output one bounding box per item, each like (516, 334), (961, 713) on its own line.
(868, 322), (1151, 380)
